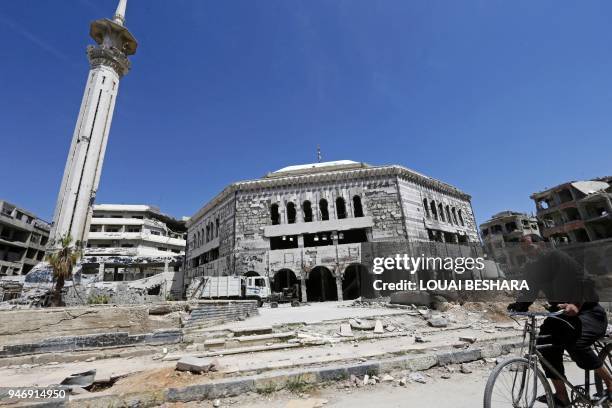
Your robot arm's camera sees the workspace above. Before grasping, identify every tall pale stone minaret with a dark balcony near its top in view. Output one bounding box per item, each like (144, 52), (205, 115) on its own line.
(49, 0), (137, 248)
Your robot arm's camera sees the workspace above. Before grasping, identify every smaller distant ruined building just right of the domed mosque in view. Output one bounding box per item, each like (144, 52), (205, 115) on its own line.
(480, 211), (541, 276)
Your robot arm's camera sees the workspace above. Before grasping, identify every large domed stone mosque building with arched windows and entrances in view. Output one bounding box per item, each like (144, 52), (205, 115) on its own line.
(185, 160), (480, 301)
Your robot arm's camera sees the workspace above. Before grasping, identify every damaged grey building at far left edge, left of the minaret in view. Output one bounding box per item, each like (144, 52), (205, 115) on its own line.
(0, 200), (50, 276)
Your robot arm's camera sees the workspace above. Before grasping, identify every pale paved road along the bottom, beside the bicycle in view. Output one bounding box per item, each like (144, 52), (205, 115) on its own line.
(235, 363), (583, 408)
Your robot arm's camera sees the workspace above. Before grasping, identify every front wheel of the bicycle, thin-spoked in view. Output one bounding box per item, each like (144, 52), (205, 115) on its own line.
(484, 357), (555, 408)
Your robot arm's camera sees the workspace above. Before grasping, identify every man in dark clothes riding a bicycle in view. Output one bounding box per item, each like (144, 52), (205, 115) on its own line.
(508, 234), (612, 407)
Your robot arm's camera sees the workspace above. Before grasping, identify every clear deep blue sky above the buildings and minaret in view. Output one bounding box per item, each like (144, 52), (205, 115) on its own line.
(0, 0), (612, 222)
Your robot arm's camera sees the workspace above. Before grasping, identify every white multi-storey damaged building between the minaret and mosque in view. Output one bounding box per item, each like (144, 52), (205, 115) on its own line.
(81, 204), (186, 290)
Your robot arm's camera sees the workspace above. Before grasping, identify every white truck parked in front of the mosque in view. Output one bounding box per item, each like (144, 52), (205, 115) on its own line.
(196, 276), (270, 306)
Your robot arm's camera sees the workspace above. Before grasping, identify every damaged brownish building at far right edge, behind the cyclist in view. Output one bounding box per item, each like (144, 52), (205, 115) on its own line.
(531, 176), (612, 244)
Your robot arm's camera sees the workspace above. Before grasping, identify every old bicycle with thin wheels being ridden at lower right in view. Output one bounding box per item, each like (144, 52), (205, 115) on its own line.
(484, 311), (612, 408)
